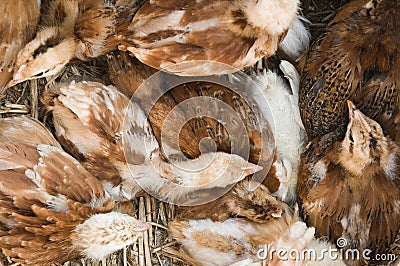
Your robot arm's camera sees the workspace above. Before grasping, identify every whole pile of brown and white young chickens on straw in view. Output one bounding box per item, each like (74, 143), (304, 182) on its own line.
(0, 0), (400, 265)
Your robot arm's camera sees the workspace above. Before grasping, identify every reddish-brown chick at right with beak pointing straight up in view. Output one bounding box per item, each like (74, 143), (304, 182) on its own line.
(297, 101), (400, 262)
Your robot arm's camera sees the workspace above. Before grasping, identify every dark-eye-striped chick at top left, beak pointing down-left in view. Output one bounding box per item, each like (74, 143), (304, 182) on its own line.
(8, 0), (141, 87)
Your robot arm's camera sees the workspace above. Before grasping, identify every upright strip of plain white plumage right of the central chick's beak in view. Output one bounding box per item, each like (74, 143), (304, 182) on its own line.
(251, 60), (306, 205)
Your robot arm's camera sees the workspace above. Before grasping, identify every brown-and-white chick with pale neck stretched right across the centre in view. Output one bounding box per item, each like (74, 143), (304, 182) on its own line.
(44, 82), (262, 204)
